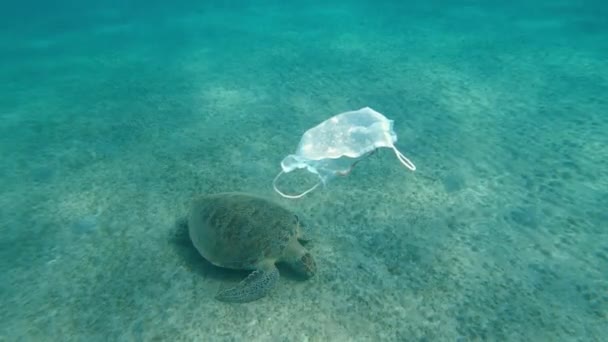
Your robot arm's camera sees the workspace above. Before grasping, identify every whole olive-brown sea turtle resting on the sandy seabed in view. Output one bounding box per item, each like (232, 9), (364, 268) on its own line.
(188, 192), (316, 302)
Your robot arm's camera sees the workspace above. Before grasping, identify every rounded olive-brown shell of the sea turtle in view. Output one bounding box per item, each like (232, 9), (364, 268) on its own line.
(188, 192), (298, 269)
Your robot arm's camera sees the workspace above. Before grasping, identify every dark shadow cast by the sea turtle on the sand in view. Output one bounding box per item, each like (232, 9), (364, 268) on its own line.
(169, 217), (307, 283)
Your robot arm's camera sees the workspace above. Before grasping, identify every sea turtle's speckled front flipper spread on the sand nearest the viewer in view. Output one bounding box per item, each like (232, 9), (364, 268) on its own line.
(215, 264), (279, 303)
